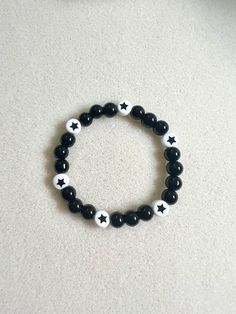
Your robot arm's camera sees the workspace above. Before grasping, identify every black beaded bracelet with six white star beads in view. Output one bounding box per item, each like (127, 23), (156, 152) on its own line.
(53, 100), (183, 228)
